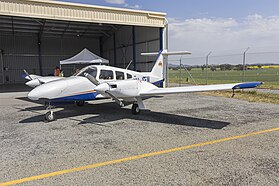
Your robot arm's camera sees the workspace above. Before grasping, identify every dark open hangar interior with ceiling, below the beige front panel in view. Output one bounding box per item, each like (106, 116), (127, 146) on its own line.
(0, 16), (162, 84)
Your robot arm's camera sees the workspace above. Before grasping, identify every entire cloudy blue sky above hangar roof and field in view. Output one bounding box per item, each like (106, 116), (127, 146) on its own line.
(58, 0), (279, 63)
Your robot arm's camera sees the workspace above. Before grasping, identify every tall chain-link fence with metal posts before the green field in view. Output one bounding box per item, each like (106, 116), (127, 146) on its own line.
(168, 49), (279, 89)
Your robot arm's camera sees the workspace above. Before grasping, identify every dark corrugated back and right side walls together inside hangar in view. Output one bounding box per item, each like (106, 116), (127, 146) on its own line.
(0, 26), (160, 84)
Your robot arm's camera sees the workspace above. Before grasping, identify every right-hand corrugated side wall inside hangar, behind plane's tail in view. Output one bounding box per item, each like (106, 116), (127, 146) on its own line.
(103, 26), (160, 71)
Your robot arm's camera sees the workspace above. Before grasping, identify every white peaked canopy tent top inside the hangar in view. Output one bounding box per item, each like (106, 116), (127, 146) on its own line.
(60, 48), (109, 65)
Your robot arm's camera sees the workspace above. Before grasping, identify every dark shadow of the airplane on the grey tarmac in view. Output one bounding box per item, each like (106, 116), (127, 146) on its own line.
(19, 102), (230, 129)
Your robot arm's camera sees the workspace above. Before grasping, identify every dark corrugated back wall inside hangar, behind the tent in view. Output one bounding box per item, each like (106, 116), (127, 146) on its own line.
(0, 33), (100, 84)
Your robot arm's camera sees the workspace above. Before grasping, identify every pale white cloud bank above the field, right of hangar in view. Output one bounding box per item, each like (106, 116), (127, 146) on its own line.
(169, 14), (279, 55)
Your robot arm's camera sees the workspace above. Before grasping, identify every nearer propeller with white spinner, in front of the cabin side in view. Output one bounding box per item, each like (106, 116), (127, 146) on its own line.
(84, 73), (125, 107)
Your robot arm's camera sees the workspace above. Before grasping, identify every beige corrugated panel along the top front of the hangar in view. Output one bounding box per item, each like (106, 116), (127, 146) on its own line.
(0, 0), (166, 27)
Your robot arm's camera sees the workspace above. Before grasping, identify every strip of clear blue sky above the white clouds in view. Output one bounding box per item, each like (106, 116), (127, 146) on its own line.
(60, 0), (279, 19)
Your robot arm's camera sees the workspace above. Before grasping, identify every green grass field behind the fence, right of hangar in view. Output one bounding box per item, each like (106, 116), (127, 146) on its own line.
(168, 68), (279, 89)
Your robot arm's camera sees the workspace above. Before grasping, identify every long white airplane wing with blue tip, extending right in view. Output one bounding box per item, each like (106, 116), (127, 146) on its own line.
(140, 82), (262, 96)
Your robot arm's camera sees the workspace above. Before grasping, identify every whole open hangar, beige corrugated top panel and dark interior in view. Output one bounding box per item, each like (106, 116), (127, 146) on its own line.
(0, 0), (166, 84)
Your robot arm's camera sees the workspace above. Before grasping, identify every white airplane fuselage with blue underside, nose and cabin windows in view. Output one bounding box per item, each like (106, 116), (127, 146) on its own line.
(28, 64), (163, 102)
